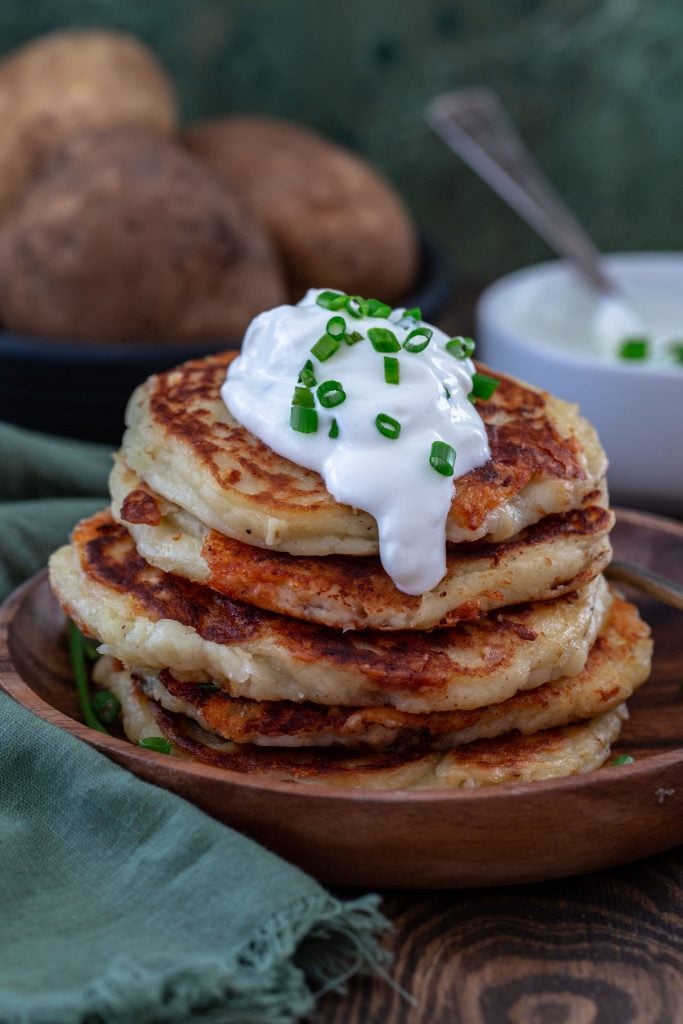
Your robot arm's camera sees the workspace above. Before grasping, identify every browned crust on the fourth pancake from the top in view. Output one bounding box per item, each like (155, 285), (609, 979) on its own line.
(149, 595), (650, 751)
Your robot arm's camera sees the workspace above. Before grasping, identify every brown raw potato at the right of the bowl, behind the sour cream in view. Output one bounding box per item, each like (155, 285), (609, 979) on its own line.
(184, 117), (418, 302)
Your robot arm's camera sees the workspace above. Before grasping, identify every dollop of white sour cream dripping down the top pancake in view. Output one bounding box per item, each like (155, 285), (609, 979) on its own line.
(221, 289), (489, 595)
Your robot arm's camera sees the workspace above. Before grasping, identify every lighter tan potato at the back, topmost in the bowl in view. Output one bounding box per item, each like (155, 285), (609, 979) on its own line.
(0, 30), (176, 210)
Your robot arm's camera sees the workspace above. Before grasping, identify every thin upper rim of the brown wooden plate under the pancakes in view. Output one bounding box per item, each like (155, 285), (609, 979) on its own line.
(0, 508), (683, 805)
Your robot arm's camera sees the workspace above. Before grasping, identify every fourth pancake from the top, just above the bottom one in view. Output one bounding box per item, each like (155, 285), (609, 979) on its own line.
(107, 596), (652, 751)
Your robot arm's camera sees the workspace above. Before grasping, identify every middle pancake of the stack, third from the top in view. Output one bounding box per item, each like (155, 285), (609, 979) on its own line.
(50, 512), (610, 712)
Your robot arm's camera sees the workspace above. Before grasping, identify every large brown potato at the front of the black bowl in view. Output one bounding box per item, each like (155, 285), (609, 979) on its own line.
(0, 128), (286, 341)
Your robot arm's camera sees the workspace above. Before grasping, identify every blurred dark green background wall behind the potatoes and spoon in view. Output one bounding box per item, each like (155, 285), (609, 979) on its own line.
(0, 0), (683, 279)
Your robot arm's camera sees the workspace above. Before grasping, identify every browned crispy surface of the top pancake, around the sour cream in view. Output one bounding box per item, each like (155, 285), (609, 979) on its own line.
(147, 352), (586, 530)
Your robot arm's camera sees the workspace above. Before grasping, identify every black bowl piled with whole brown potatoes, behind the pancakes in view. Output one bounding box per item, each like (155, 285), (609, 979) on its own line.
(0, 31), (453, 442)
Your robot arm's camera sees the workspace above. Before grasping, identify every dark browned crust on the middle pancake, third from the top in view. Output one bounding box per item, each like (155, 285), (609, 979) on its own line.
(73, 511), (593, 693)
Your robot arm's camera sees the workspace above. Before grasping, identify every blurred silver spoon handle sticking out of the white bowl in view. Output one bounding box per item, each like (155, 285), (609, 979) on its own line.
(425, 87), (618, 294)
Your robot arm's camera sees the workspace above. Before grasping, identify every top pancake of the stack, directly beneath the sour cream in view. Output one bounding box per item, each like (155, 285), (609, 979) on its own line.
(122, 353), (606, 555)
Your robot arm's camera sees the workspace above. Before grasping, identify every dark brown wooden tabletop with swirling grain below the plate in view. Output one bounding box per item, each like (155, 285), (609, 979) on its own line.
(311, 287), (683, 1024)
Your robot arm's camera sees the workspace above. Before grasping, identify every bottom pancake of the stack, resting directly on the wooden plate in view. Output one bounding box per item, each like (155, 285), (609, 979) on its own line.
(102, 673), (628, 790)
